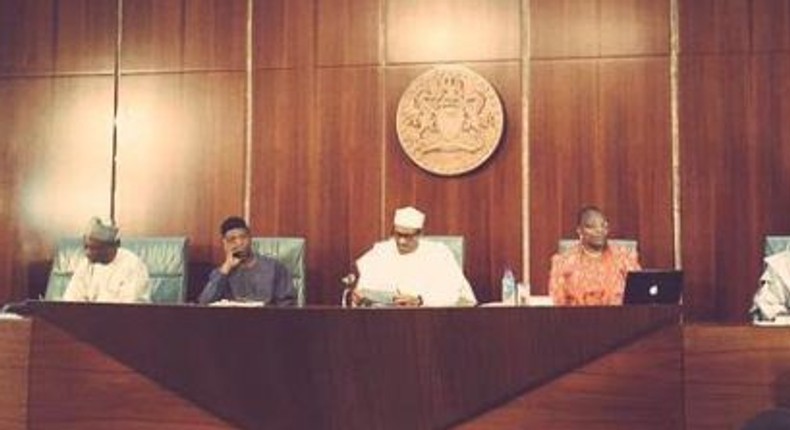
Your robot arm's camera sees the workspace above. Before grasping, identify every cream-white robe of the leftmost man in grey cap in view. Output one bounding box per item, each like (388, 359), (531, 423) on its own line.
(63, 248), (151, 303)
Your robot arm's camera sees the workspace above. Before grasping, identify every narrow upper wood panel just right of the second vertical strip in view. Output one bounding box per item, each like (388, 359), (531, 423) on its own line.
(253, 0), (315, 68)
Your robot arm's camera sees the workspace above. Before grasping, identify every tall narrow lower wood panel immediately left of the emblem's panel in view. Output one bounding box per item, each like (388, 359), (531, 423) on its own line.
(310, 68), (382, 304)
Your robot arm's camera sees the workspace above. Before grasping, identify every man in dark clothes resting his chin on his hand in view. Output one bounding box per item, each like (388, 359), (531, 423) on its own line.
(198, 216), (296, 306)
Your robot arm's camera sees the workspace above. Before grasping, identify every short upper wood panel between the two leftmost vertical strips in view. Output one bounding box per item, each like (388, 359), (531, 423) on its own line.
(121, 0), (247, 72)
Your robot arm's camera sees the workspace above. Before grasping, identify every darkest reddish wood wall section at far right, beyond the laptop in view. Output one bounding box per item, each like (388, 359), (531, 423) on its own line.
(679, 0), (790, 321)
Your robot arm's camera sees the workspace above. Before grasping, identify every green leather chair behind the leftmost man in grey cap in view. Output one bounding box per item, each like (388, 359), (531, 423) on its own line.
(45, 236), (188, 303)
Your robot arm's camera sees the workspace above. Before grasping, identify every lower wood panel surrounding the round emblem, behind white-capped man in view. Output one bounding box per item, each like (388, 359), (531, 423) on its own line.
(384, 63), (523, 301)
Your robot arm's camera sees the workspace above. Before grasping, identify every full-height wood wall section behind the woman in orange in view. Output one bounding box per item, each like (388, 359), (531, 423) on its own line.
(528, 0), (674, 293)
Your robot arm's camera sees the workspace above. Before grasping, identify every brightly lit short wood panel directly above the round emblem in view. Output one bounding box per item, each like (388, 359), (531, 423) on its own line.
(384, 0), (521, 63)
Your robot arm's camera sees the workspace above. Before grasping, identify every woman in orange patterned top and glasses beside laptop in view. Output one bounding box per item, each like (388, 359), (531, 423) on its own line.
(549, 206), (641, 306)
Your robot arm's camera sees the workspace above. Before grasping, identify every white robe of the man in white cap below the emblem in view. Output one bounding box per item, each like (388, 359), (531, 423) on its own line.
(357, 239), (477, 306)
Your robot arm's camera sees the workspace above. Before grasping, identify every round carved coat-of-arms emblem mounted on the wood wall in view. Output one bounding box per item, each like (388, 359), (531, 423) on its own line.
(396, 66), (504, 176)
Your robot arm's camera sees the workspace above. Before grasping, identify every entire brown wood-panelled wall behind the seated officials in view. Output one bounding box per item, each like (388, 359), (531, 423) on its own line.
(0, 0), (790, 320)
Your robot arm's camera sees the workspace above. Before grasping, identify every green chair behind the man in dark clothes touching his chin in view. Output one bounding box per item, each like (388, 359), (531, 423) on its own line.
(252, 237), (307, 307)
